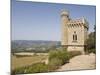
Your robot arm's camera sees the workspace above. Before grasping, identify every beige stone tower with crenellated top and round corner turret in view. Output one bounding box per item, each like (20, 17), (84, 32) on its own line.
(61, 10), (89, 53)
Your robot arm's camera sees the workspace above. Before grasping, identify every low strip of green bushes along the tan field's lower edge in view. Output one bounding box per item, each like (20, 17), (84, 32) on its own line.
(12, 63), (48, 75)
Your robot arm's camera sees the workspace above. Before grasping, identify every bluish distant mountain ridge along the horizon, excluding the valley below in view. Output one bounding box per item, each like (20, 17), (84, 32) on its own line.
(11, 40), (60, 49)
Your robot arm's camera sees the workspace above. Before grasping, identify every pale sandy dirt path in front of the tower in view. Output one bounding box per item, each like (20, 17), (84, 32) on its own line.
(57, 54), (96, 71)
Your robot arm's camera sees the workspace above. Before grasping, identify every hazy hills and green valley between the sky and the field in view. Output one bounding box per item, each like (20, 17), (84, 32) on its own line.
(11, 40), (60, 52)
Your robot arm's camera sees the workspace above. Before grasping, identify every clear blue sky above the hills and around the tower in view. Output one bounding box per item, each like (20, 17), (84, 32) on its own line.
(11, 0), (96, 41)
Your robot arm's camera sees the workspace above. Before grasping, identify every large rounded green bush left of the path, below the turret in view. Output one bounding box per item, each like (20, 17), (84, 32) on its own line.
(49, 50), (69, 66)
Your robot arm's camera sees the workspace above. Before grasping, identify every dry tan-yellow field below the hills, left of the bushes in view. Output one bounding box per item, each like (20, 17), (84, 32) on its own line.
(11, 55), (48, 70)
